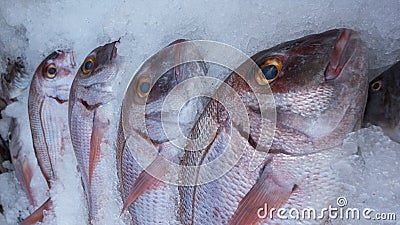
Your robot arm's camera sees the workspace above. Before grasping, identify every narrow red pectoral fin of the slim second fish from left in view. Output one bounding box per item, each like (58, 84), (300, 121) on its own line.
(89, 117), (109, 187)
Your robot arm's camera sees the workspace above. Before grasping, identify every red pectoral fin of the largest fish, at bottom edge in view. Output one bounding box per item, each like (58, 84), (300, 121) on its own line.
(229, 168), (295, 225)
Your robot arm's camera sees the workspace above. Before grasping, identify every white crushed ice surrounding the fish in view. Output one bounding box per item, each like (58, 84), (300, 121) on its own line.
(0, 0), (400, 224)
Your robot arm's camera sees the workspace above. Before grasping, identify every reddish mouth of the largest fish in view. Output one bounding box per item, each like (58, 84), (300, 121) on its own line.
(325, 29), (359, 80)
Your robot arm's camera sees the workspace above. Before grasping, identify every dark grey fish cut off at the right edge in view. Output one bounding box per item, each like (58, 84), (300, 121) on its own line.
(363, 62), (400, 143)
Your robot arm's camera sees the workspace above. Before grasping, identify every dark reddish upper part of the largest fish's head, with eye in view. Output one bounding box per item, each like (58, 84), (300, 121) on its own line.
(252, 29), (361, 93)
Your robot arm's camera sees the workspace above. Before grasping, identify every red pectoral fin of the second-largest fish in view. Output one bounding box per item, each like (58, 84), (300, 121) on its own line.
(121, 157), (167, 214)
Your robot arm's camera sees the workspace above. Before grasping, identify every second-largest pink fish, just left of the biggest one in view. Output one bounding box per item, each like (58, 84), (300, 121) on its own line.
(117, 39), (209, 224)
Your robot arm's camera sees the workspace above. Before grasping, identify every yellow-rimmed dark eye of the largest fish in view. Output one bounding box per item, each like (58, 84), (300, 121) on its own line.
(256, 58), (282, 85)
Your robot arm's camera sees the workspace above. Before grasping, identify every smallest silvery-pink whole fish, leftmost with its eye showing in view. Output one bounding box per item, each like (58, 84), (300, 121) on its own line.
(21, 49), (76, 225)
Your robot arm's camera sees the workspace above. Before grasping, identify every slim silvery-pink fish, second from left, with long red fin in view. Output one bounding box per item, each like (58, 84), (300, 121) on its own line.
(68, 40), (122, 224)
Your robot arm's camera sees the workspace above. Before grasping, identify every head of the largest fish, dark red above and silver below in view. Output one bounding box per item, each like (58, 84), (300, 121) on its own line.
(250, 29), (368, 150)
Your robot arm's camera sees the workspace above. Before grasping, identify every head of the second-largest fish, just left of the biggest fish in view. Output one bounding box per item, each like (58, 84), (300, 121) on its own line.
(123, 39), (207, 143)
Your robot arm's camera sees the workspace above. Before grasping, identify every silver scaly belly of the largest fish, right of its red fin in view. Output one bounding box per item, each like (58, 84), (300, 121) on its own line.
(258, 147), (340, 225)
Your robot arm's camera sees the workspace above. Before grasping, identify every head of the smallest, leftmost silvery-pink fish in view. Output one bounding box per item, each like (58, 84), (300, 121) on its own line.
(31, 49), (76, 103)
